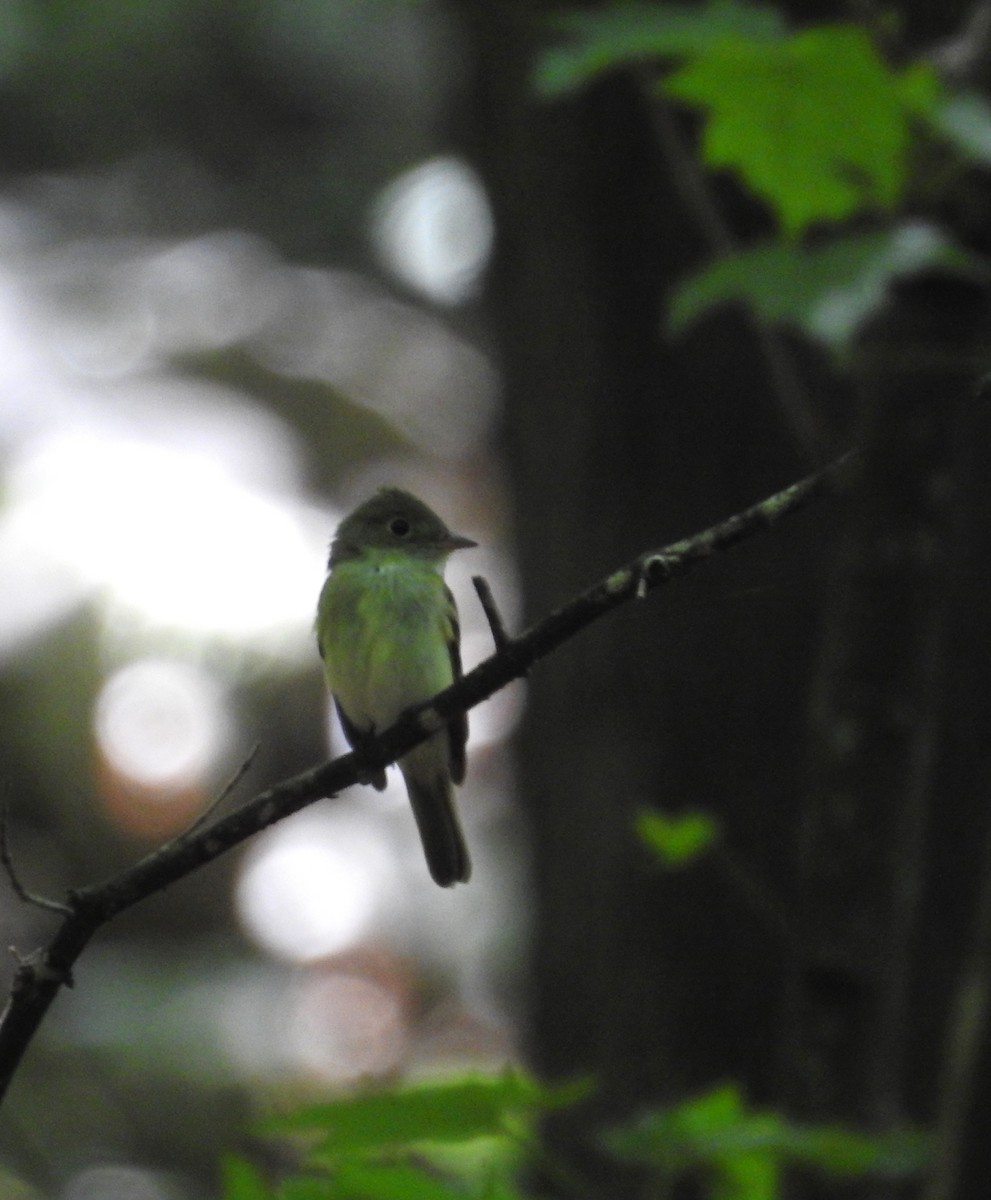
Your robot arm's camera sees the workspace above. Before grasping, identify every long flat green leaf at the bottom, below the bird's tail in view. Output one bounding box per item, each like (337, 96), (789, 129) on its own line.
(263, 1072), (576, 1153)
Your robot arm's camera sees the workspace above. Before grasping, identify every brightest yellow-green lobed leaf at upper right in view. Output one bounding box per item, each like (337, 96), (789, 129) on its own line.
(662, 25), (939, 236)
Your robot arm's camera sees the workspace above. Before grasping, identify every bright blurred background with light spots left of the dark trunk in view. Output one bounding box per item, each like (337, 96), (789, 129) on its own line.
(0, 0), (525, 1200)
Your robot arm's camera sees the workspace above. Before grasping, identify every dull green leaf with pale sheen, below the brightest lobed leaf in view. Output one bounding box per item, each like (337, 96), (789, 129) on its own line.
(668, 222), (984, 352)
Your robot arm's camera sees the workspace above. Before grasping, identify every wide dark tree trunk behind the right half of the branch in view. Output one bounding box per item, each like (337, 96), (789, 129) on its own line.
(462, 5), (822, 1194)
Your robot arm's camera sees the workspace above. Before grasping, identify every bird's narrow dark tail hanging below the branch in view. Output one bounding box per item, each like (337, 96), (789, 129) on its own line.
(400, 734), (472, 888)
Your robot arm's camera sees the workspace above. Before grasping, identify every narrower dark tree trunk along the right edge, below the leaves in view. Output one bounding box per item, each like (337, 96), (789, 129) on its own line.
(785, 277), (991, 1200)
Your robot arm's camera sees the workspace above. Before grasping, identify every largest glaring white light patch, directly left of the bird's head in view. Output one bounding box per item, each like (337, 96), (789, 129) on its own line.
(0, 427), (331, 643)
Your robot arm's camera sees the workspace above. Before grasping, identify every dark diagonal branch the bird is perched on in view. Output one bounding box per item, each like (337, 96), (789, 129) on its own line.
(0, 455), (851, 1100)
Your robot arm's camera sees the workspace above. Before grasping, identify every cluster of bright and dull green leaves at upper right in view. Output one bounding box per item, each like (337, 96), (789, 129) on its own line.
(534, 0), (991, 355)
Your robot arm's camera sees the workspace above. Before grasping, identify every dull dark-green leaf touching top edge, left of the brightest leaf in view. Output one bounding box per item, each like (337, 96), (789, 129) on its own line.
(535, 0), (786, 96)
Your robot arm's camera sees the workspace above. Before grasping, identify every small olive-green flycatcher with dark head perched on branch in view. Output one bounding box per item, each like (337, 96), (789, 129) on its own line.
(317, 487), (478, 888)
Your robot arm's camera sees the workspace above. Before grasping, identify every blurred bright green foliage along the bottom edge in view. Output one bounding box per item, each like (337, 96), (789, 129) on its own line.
(223, 1072), (929, 1200)
